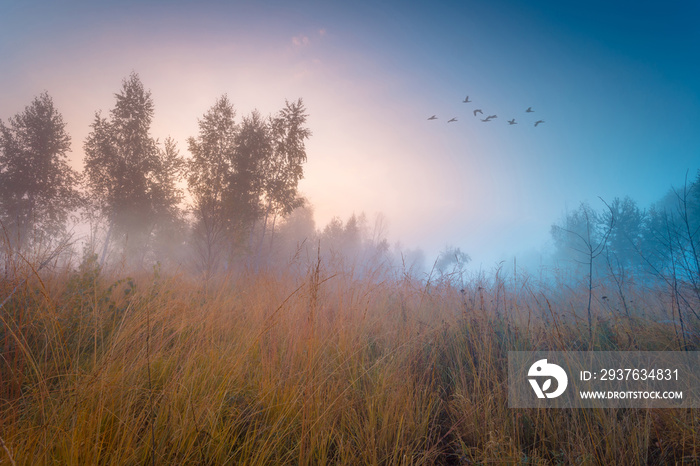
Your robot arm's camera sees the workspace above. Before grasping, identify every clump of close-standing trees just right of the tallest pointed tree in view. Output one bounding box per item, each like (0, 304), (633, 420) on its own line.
(188, 95), (311, 272)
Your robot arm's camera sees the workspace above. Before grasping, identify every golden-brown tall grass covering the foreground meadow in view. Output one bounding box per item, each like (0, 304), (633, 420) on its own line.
(0, 253), (700, 465)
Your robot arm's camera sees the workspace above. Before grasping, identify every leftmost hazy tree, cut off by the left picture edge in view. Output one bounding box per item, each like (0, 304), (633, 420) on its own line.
(0, 92), (80, 248)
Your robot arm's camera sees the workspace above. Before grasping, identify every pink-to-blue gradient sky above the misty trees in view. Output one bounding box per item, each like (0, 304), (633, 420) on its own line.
(0, 0), (700, 269)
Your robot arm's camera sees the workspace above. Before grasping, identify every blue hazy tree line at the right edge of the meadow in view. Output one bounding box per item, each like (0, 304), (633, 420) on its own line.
(551, 181), (700, 287)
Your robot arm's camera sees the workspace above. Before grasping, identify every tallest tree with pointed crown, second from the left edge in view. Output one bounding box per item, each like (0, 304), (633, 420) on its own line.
(84, 73), (184, 261)
